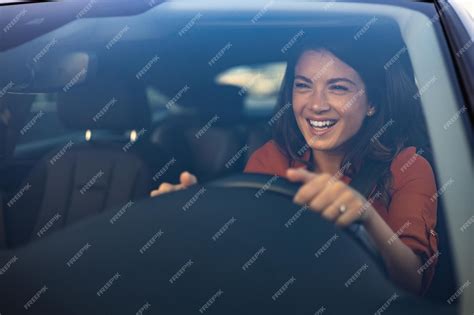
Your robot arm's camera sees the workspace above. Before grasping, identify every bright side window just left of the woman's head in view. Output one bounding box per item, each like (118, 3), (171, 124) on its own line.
(216, 62), (286, 116)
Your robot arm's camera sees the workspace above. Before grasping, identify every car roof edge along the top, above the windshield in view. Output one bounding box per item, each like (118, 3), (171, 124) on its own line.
(0, 0), (432, 52)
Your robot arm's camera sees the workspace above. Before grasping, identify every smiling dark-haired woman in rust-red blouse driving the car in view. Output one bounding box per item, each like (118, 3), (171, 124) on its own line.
(245, 39), (437, 294)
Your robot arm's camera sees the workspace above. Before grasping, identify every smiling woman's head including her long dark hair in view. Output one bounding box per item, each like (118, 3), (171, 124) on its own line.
(273, 38), (430, 203)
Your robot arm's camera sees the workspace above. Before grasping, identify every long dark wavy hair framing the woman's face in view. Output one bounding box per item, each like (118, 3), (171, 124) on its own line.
(272, 38), (430, 206)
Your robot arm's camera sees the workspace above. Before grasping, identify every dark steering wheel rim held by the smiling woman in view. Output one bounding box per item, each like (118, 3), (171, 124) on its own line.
(209, 173), (386, 273)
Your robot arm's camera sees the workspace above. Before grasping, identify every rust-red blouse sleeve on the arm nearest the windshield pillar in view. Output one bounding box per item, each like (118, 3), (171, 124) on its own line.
(387, 147), (439, 294)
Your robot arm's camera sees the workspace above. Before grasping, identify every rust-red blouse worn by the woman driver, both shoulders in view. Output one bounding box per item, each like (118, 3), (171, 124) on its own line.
(244, 140), (439, 294)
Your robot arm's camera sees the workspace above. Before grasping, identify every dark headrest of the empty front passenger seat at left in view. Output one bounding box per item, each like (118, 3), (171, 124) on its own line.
(58, 79), (151, 131)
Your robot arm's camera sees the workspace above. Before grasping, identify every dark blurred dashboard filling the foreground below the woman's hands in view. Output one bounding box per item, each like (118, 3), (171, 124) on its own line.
(0, 174), (400, 315)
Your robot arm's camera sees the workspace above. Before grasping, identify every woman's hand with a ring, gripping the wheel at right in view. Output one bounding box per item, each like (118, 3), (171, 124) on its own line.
(286, 168), (375, 226)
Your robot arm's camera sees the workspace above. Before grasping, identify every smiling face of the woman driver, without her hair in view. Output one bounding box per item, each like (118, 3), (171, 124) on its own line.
(293, 50), (373, 151)
